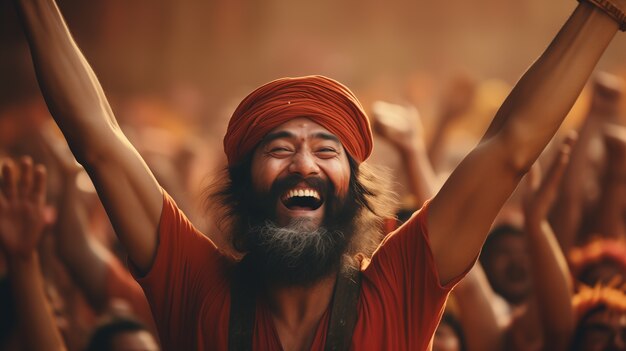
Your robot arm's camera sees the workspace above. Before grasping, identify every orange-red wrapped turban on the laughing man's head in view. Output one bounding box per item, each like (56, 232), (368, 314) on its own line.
(224, 76), (372, 166)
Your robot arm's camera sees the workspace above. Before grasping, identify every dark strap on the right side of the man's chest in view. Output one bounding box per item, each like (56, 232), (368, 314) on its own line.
(324, 268), (361, 351)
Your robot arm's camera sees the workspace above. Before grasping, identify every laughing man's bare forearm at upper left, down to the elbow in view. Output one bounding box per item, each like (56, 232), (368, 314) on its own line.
(15, 0), (118, 155)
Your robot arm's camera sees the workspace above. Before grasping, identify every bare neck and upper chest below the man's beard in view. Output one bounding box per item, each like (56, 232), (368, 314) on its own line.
(267, 272), (337, 350)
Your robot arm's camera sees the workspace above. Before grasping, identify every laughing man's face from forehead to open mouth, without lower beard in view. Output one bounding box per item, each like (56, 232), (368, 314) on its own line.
(251, 118), (350, 228)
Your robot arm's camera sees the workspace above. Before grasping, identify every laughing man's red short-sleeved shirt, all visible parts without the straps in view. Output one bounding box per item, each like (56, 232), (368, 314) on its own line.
(137, 194), (462, 350)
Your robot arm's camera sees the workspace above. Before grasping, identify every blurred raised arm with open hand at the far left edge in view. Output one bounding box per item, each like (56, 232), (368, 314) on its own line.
(0, 158), (65, 351)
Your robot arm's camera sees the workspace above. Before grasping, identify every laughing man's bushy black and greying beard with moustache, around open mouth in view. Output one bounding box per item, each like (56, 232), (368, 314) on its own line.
(242, 175), (360, 286)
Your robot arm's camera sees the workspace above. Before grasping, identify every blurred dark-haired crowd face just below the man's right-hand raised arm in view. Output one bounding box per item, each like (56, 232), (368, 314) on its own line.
(481, 234), (531, 304)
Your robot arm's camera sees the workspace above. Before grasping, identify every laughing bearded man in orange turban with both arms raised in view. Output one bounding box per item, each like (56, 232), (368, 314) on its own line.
(16, 0), (626, 350)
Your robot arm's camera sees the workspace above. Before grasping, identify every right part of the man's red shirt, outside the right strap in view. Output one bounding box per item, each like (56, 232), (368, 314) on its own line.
(353, 203), (469, 350)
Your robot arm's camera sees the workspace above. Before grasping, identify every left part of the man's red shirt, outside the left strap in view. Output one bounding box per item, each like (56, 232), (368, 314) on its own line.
(131, 191), (233, 350)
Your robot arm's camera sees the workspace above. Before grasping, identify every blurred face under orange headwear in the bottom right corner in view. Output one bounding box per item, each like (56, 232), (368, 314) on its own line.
(572, 308), (626, 351)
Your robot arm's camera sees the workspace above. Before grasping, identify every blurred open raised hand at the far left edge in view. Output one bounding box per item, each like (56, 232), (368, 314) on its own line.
(0, 157), (46, 258)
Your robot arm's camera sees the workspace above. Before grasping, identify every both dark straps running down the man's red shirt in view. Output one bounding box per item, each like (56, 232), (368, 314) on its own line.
(228, 269), (361, 351)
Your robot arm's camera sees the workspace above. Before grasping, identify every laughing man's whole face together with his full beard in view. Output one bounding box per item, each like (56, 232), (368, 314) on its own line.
(247, 118), (359, 284)
